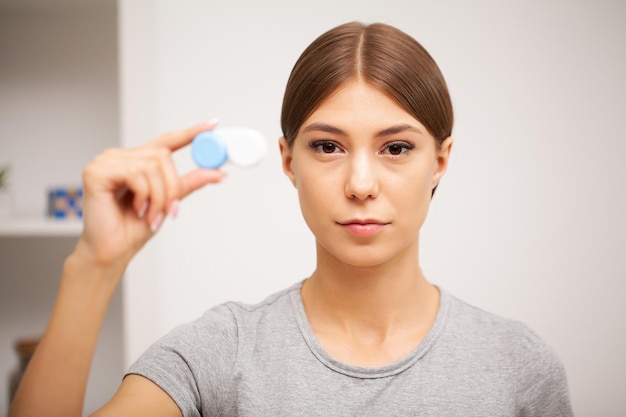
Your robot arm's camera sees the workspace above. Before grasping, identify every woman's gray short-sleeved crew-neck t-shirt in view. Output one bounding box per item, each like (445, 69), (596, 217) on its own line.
(129, 283), (573, 417)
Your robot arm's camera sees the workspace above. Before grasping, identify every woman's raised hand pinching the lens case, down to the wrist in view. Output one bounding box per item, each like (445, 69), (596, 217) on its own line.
(75, 122), (225, 268)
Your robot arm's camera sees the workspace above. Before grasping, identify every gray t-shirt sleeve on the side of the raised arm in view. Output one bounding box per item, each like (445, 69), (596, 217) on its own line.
(127, 305), (237, 417)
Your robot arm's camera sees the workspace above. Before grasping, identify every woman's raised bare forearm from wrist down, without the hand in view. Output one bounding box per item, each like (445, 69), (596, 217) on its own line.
(9, 249), (123, 417)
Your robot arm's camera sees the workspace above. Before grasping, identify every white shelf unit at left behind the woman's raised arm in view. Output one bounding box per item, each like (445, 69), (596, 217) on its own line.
(0, 0), (124, 416)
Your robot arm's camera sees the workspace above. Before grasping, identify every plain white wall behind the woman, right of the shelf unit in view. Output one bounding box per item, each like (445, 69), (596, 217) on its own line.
(121, 0), (626, 417)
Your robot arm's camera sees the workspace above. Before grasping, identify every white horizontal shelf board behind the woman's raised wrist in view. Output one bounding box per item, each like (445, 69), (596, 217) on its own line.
(0, 216), (83, 237)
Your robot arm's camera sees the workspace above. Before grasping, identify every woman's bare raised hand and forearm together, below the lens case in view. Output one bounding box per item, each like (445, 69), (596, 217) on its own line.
(9, 123), (224, 417)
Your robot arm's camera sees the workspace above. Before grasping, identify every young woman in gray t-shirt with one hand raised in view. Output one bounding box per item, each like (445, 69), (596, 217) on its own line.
(10, 23), (572, 417)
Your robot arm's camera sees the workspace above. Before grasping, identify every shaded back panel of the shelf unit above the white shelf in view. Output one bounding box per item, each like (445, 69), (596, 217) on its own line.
(0, 0), (119, 216)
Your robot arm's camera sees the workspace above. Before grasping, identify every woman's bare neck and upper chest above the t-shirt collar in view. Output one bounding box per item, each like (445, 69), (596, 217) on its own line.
(301, 239), (439, 367)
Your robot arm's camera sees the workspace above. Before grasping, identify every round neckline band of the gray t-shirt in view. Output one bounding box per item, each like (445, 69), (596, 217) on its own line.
(291, 281), (450, 379)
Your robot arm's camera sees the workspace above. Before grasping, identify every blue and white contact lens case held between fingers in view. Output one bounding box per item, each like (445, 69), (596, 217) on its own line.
(191, 127), (267, 169)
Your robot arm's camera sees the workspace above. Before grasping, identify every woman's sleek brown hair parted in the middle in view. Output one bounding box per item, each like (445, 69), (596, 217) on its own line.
(281, 22), (453, 146)
